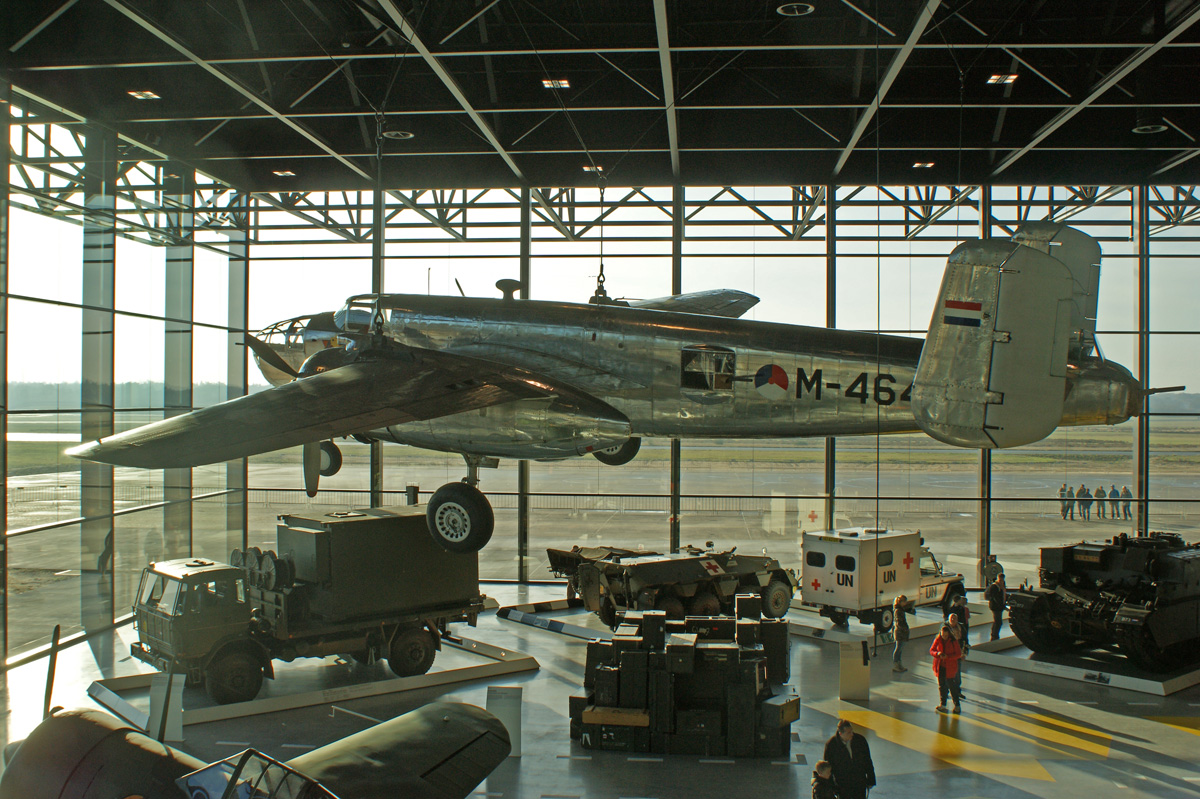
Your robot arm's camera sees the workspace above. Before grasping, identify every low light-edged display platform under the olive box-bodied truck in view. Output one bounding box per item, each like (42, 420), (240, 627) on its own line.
(88, 637), (540, 729)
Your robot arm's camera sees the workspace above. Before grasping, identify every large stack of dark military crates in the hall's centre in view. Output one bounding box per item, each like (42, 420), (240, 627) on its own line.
(569, 594), (800, 757)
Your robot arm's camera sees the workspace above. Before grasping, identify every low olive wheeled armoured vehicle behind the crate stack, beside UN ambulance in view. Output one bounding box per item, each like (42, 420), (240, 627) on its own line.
(546, 541), (796, 629)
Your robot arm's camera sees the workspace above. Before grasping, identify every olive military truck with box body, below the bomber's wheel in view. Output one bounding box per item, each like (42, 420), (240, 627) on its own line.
(132, 507), (484, 704)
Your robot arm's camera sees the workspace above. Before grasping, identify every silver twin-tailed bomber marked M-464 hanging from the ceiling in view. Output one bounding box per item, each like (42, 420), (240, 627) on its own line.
(67, 222), (1151, 552)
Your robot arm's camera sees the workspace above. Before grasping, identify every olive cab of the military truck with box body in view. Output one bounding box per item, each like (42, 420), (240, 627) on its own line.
(132, 558), (253, 683)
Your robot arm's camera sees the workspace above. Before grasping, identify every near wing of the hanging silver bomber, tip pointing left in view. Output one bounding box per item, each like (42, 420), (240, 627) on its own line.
(67, 344), (620, 469)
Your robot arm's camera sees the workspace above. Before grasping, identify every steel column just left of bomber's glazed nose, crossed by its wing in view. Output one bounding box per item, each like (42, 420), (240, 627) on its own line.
(222, 193), (251, 557)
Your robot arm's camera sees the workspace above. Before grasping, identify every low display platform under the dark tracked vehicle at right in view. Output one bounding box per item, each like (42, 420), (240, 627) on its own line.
(968, 636), (1200, 696)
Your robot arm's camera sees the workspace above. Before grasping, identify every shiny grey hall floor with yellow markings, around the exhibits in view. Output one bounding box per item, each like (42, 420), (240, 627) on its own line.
(0, 584), (1200, 799)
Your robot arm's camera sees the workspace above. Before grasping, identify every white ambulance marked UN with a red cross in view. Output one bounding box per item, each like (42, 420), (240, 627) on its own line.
(800, 527), (966, 631)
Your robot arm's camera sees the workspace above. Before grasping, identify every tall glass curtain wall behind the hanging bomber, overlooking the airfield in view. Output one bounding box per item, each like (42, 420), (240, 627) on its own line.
(4, 97), (1200, 657)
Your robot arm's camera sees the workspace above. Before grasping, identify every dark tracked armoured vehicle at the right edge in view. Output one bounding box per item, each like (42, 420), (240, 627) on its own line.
(1008, 533), (1200, 672)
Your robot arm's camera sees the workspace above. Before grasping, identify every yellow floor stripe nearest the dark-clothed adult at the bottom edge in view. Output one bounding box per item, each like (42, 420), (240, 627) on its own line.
(838, 710), (1055, 782)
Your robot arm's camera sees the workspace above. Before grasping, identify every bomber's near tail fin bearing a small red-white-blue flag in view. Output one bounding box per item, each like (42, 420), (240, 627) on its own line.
(912, 240), (1073, 449)
